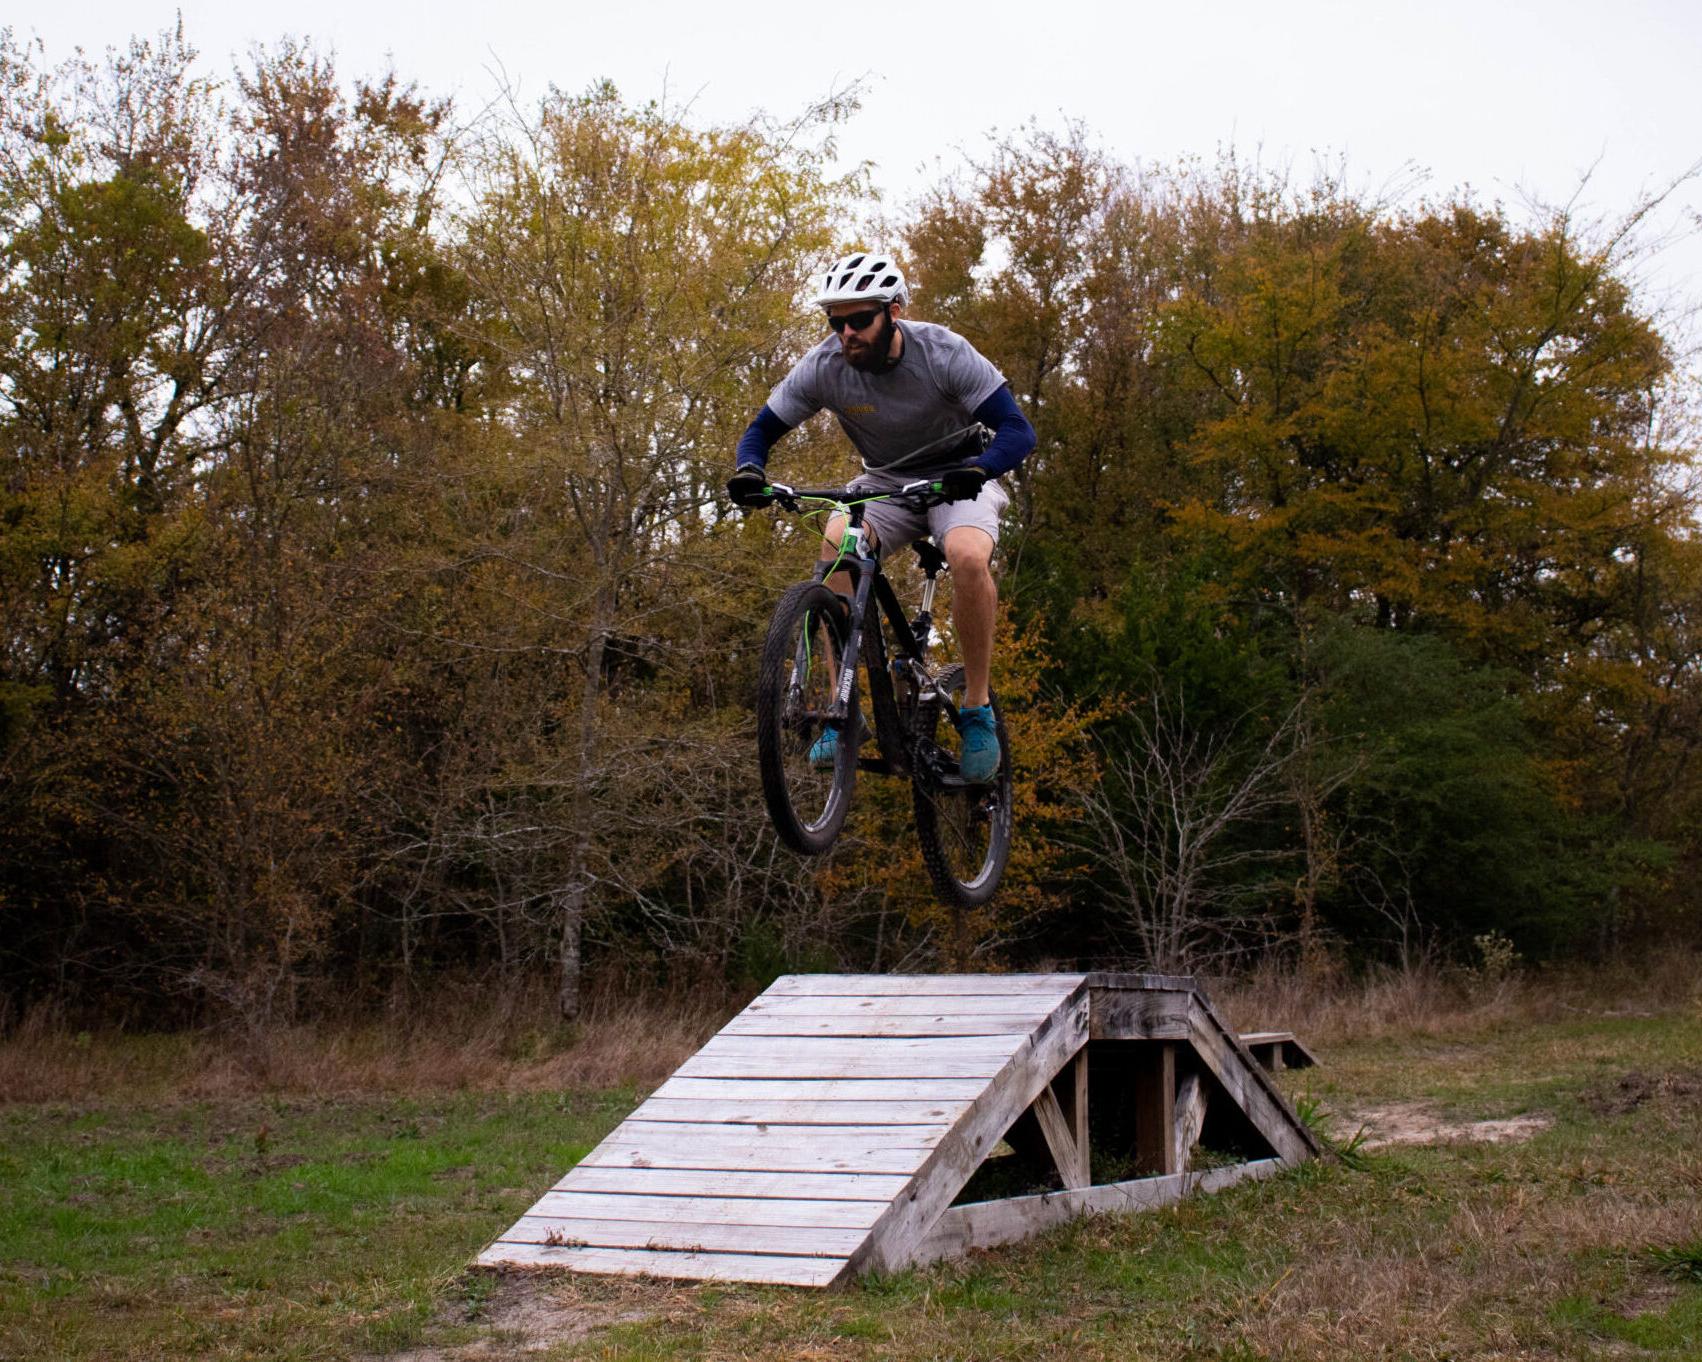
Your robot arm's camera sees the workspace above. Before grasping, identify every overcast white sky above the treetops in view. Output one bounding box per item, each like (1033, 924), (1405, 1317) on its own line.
(10, 0), (1702, 340)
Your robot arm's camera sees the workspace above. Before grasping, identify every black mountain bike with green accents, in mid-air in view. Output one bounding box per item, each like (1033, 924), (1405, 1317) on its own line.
(756, 426), (1011, 907)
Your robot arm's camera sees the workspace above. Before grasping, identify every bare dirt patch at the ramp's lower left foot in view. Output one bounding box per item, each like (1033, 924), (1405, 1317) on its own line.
(366, 1272), (660, 1362)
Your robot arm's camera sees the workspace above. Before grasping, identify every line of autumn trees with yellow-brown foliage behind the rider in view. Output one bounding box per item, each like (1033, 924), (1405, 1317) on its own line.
(0, 34), (1702, 1023)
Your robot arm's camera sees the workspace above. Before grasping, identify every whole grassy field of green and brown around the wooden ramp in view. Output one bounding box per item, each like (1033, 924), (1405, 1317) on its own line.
(0, 976), (1702, 1362)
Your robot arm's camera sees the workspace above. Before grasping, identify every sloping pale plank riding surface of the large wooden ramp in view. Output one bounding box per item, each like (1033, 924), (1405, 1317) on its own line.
(482, 976), (1088, 1284)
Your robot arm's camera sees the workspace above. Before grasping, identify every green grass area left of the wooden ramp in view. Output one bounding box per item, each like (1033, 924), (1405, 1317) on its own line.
(0, 1093), (630, 1360)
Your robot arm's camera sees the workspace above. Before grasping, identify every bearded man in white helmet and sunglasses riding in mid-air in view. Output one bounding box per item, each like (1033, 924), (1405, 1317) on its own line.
(727, 250), (1035, 781)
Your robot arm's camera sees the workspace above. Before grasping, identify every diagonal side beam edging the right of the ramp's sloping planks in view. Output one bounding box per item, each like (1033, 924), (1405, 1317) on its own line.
(849, 989), (1088, 1272)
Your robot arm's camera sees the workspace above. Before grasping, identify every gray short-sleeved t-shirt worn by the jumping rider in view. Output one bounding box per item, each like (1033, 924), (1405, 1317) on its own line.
(768, 322), (1004, 468)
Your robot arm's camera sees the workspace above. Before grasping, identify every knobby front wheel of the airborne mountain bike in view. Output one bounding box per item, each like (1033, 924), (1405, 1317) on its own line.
(756, 582), (858, 855)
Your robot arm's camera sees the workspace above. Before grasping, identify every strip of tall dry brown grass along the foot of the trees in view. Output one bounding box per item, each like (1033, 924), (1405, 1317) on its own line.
(0, 952), (1702, 1105)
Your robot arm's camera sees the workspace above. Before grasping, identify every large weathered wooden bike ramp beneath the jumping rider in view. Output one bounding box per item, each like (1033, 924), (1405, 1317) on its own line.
(478, 974), (1317, 1285)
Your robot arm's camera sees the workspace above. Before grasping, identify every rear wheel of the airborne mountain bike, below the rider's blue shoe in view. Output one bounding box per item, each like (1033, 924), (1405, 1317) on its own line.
(911, 666), (1011, 907)
